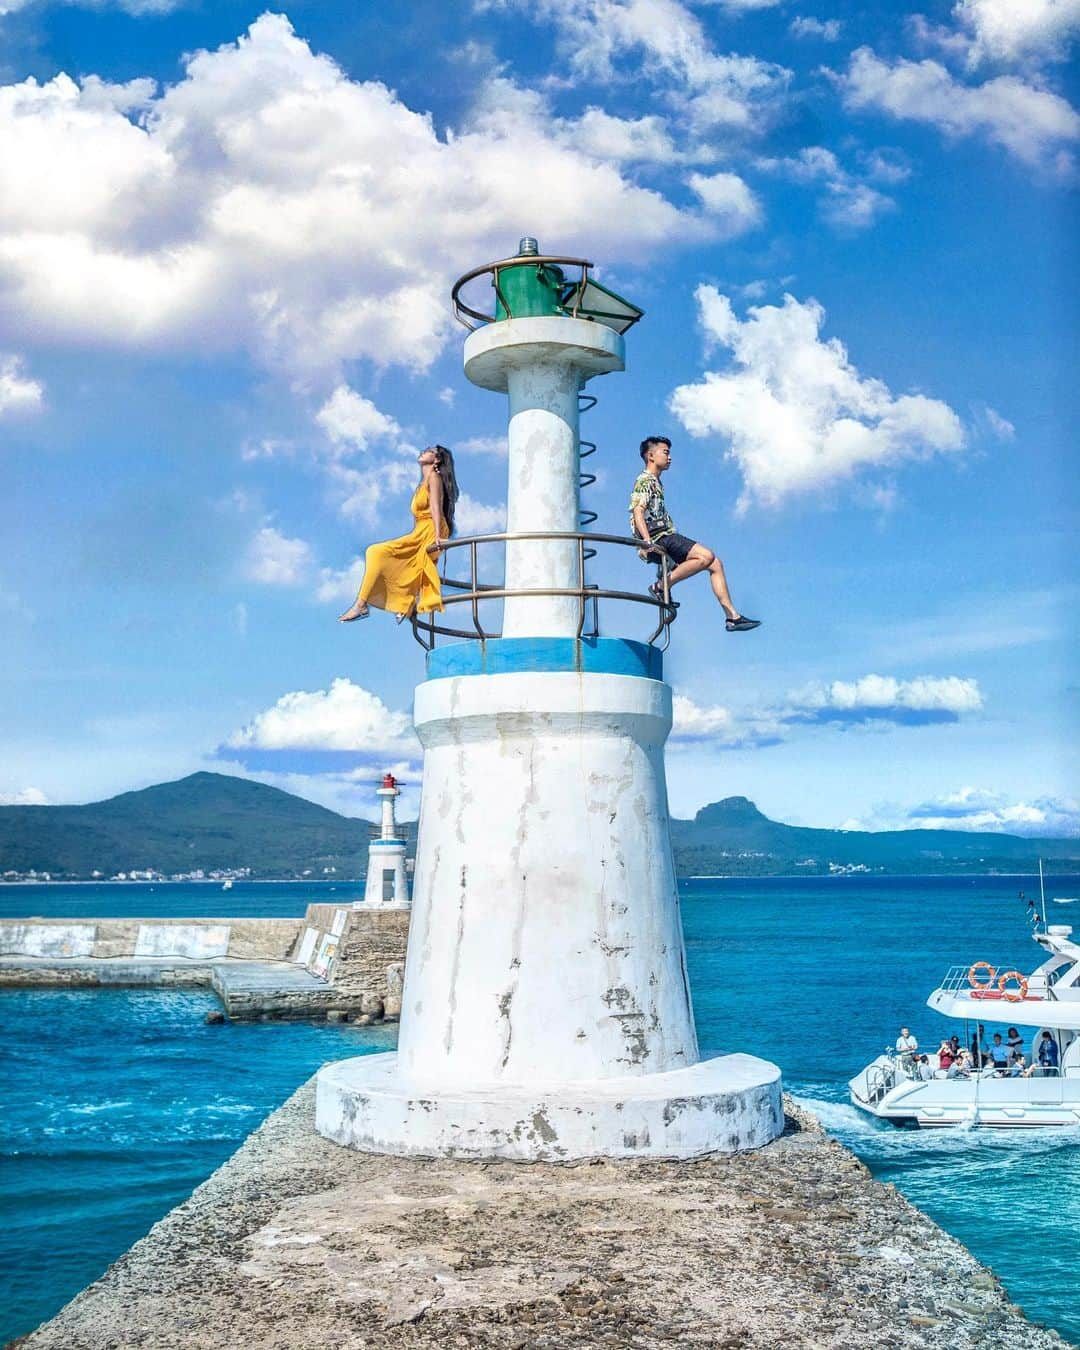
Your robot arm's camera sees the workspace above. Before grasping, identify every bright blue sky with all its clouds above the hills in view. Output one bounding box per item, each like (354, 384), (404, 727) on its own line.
(0, 0), (1080, 834)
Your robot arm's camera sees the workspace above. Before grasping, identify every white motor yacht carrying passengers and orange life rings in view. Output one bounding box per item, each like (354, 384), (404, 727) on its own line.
(849, 923), (1080, 1129)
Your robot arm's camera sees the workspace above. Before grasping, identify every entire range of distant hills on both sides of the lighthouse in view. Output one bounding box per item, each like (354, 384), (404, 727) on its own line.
(0, 774), (1080, 879)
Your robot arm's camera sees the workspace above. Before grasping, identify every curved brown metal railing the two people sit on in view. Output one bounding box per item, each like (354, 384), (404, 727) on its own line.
(412, 531), (675, 651)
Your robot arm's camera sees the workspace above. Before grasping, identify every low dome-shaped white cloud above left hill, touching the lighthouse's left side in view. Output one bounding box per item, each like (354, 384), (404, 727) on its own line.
(225, 678), (417, 759)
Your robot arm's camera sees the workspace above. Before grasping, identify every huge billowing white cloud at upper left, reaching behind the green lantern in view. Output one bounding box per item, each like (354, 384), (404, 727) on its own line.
(0, 14), (702, 382)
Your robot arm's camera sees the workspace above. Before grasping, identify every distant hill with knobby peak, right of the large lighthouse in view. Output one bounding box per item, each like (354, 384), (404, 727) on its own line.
(671, 797), (1080, 876)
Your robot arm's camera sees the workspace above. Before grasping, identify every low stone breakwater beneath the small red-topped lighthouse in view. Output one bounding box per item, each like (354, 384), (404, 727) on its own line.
(0, 905), (409, 1023)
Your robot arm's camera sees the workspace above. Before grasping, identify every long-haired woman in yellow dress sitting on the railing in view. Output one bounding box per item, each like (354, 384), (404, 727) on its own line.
(340, 446), (458, 624)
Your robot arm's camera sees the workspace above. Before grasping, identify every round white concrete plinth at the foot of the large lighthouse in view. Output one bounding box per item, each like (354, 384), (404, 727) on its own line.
(316, 1054), (783, 1162)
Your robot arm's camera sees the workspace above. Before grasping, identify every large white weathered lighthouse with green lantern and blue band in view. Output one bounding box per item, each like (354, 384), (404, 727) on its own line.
(316, 240), (783, 1160)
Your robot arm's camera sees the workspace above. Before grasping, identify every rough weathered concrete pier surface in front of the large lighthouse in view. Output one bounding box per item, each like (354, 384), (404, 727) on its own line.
(12, 1084), (1064, 1350)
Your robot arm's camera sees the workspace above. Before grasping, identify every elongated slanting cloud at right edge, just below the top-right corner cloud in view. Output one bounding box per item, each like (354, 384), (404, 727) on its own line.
(840, 47), (1080, 171)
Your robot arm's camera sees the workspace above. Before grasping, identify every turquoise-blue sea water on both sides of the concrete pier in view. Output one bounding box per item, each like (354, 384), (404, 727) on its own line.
(0, 876), (1080, 1343)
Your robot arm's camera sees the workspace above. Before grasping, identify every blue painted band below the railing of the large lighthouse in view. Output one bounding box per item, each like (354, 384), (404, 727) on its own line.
(428, 637), (664, 679)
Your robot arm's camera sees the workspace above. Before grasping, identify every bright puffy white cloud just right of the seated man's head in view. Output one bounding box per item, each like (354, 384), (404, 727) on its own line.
(670, 286), (965, 510)
